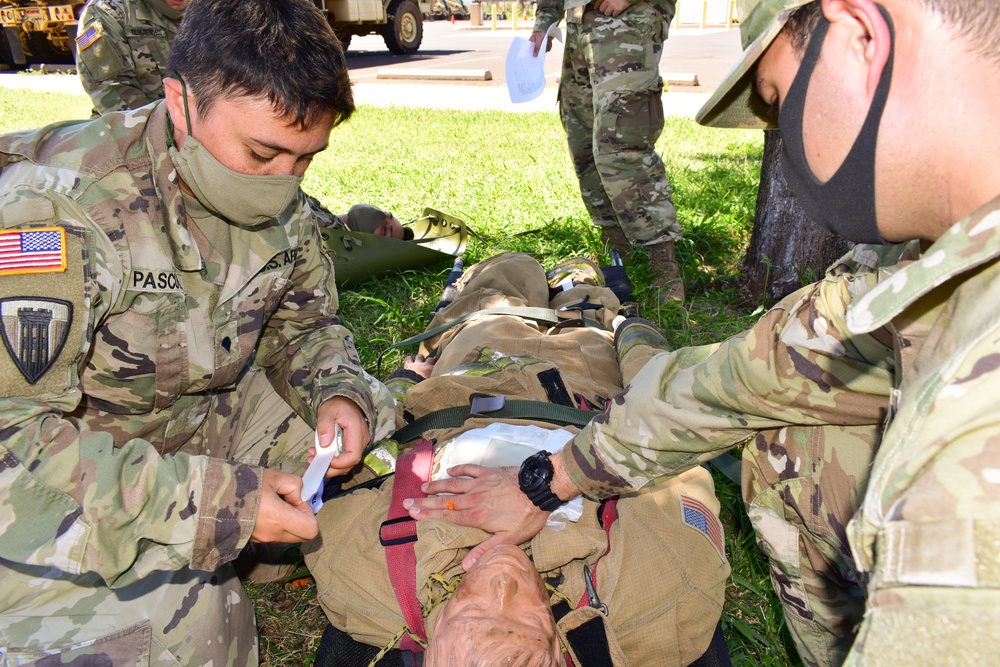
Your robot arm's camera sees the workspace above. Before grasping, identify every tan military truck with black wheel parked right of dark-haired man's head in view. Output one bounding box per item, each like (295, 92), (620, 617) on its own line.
(313, 0), (431, 55)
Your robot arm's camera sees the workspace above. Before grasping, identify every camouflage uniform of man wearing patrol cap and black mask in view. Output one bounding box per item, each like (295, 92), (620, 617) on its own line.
(568, 198), (1000, 665)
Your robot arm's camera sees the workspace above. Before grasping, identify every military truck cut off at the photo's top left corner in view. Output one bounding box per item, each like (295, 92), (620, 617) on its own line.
(0, 0), (85, 69)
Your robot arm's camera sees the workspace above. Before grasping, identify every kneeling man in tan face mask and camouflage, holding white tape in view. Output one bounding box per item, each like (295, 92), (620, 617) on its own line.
(0, 0), (394, 666)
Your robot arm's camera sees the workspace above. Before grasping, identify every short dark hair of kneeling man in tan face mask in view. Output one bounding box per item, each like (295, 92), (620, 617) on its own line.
(167, 0), (354, 126)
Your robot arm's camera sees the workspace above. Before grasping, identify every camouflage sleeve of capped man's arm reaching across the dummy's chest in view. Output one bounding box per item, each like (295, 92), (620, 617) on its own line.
(564, 248), (895, 498)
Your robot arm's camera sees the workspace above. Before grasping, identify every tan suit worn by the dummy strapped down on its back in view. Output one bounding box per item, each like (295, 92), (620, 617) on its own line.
(303, 254), (729, 667)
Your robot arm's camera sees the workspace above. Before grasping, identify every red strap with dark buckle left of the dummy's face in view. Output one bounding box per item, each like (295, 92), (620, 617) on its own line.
(379, 438), (434, 653)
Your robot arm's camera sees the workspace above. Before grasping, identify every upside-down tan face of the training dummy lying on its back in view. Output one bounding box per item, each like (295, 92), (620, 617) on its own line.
(425, 545), (560, 667)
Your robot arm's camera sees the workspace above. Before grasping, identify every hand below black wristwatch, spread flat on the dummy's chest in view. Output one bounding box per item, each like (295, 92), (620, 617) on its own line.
(403, 465), (549, 571)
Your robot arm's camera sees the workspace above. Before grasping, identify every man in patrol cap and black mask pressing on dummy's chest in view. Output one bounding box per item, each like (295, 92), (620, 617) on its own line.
(411, 0), (1000, 665)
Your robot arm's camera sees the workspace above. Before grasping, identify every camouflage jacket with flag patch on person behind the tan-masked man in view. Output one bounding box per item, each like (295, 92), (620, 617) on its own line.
(76, 0), (180, 115)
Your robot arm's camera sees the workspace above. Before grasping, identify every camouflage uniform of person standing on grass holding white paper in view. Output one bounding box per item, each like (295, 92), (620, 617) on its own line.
(534, 0), (681, 244)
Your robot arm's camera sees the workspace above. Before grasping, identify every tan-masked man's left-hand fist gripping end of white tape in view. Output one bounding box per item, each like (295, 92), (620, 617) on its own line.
(250, 469), (319, 544)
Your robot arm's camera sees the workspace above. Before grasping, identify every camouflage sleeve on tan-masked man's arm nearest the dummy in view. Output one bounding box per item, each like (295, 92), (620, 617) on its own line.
(257, 207), (396, 442)
